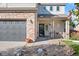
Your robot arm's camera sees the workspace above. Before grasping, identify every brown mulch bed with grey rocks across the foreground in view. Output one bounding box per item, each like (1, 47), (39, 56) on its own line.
(2, 44), (74, 56)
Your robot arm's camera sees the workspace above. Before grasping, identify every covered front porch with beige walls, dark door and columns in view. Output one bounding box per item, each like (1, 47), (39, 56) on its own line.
(36, 17), (69, 41)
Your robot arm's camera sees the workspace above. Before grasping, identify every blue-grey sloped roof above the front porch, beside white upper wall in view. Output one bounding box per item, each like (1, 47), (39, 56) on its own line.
(37, 3), (67, 17)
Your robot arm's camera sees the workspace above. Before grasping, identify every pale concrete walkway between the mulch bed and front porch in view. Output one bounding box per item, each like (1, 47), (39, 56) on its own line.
(26, 39), (64, 46)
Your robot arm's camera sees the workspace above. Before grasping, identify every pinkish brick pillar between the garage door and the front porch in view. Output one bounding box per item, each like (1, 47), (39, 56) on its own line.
(26, 14), (36, 41)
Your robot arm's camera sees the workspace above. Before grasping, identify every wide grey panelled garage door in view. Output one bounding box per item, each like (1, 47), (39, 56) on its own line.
(0, 21), (26, 41)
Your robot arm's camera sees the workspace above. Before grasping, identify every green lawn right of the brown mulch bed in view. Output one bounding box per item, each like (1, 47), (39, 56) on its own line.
(64, 41), (79, 56)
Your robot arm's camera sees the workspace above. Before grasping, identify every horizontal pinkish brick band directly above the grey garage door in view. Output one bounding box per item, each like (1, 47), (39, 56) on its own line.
(0, 13), (34, 19)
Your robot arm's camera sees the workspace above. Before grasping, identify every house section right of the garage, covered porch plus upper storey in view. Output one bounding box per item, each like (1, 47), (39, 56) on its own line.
(37, 3), (69, 39)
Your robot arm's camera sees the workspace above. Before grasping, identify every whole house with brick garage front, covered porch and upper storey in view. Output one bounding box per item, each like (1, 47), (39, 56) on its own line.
(0, 3), (69, 41)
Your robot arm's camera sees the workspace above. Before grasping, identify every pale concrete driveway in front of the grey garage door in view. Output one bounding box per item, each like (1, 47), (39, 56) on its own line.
(0, 41), (26, 51)
